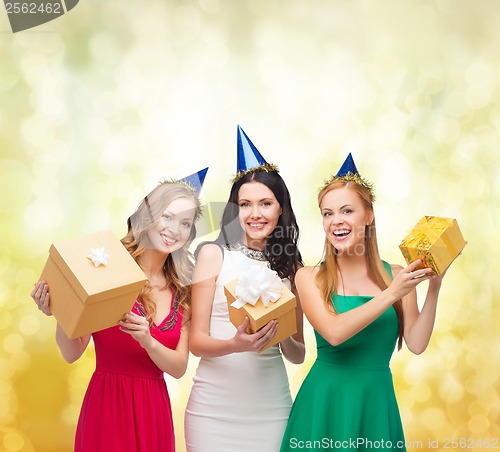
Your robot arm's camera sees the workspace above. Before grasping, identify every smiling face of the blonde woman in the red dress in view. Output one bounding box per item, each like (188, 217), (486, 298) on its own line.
(148, 197), (197, 254)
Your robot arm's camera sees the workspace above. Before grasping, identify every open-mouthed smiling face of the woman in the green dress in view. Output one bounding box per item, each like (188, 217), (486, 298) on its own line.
(320, 187), (373, 255)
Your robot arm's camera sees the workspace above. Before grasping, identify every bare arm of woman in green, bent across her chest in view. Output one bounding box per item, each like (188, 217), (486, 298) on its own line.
(296, 261), (430, 345)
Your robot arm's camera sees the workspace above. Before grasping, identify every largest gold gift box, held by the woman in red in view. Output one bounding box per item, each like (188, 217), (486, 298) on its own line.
(40, 231), (147, 339)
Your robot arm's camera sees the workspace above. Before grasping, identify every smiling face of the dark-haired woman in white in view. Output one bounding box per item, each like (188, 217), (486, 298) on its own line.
(238, 181), (281, 249)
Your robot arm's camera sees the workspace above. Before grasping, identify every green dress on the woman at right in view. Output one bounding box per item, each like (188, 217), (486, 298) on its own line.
(280, 262), (406, 452)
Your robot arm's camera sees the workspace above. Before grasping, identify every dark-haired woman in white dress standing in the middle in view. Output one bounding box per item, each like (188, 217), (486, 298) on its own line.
(184, 129), (305, 452)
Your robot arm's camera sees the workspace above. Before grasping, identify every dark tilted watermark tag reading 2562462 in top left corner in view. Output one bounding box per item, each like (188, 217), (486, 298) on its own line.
(4, 0), (79, 33)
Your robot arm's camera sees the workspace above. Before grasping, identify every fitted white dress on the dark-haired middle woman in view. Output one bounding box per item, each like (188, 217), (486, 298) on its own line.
(184, 244), (292, 452)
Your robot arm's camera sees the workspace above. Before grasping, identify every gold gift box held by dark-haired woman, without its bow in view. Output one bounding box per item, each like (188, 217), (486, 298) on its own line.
(224, 278), (297, 350)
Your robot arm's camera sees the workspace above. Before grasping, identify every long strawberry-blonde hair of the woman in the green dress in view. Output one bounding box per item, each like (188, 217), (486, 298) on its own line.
(316, 180), (404, 350)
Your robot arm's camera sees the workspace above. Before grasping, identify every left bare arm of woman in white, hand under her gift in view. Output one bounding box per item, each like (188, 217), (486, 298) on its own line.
(189, 244), (277, 357)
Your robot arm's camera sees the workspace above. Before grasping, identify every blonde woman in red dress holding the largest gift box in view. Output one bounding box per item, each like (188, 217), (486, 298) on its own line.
(31, 174), (205, 452)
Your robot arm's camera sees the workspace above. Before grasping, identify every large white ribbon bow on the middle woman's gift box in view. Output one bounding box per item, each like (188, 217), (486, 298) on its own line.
(231, 265), (283, 309)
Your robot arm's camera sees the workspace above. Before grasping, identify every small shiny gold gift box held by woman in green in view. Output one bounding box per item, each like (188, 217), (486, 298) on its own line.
(399, 216), (467, 275)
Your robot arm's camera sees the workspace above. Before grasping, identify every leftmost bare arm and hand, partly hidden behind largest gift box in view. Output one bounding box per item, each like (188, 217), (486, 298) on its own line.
(31, 281), (90, 363)
